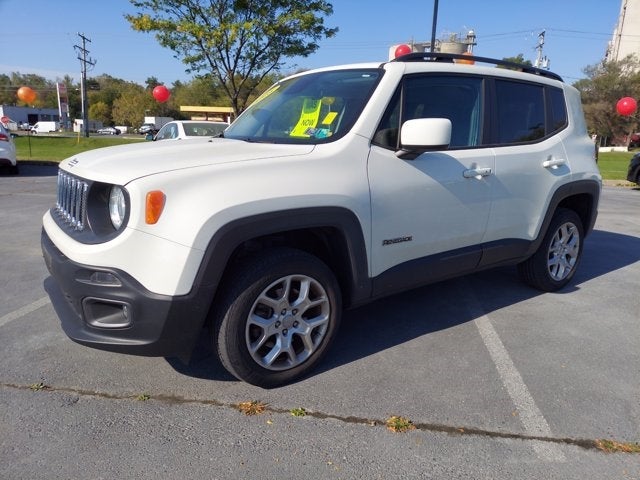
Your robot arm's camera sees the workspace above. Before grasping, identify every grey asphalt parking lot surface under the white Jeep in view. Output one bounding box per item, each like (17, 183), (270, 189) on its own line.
(0, 165), (640, 480)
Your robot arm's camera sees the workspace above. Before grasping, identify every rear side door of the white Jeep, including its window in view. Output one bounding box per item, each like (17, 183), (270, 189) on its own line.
(484, 79), (571, 248)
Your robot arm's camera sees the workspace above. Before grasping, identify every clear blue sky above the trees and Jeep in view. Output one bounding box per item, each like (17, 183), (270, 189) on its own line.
(0, 0), (621, 86)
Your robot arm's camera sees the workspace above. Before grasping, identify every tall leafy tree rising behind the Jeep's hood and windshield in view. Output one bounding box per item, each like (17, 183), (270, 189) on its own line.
(125, 0), (338, 114)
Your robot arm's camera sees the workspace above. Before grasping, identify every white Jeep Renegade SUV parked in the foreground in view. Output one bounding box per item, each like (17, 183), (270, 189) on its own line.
(42, 53), (601, 387)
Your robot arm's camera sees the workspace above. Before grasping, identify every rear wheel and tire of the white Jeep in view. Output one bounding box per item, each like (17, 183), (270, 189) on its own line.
(518, 208), (584, 292)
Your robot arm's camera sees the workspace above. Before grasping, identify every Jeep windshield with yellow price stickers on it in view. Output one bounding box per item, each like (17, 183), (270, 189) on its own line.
(224, 68), (382, 144)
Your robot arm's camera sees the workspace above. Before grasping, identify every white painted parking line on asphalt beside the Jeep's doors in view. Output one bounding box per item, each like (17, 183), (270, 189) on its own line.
(465, 289), (566, 462)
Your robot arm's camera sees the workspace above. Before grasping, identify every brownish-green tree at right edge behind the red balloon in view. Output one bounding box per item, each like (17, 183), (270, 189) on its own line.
(574, 55), (640, 145)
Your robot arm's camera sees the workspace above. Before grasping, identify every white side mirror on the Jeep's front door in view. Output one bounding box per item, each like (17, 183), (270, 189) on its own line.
(396, 118), (451, 160)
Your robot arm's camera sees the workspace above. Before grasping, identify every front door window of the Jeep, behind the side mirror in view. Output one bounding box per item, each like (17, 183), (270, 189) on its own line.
(373, 75), (483, 149)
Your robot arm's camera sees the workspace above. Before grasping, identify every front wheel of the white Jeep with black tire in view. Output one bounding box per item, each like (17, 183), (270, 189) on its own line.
(213, 248), (342, 388)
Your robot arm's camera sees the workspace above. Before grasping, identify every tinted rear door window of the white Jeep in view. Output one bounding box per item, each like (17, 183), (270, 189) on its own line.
(495, 80), (545, 143)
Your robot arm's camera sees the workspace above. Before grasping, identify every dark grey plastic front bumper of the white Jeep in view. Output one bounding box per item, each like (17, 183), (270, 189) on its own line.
(41, 229), (215, 360)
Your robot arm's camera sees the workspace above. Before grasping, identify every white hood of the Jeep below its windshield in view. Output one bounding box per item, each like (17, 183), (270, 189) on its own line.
(60, 138), (314, 185)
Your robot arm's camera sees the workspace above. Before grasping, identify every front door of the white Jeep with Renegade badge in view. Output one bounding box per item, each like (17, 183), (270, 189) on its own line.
(368, 74), (495, 289)
